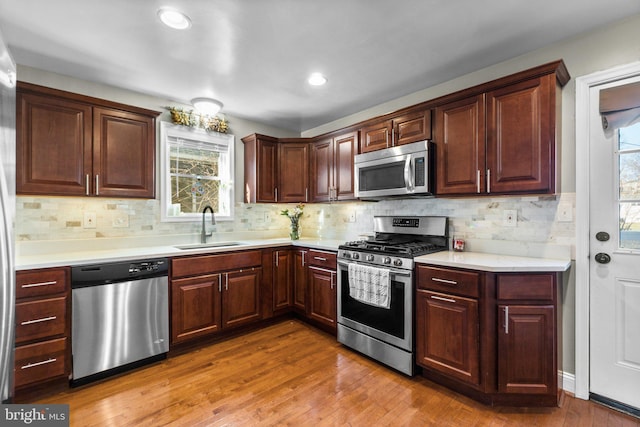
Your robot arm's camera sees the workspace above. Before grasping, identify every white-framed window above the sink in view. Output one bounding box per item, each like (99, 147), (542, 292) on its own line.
(160, 122), (234, 221)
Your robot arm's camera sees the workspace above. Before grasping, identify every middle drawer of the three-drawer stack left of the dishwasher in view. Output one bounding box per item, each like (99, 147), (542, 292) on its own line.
(16, 297), (67, 343)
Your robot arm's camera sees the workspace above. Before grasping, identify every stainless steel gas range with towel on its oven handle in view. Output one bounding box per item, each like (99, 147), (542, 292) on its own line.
(338, 216), (448, 375)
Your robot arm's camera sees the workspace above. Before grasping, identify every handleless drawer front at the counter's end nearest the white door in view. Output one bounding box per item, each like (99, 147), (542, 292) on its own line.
(496, 273), (556, 301)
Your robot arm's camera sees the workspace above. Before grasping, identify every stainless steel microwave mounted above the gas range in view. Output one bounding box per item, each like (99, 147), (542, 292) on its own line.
(354, 141), (435, 200)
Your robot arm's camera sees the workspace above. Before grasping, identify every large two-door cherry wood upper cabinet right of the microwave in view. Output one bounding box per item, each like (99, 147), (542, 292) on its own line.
(435, 61), (569, 196)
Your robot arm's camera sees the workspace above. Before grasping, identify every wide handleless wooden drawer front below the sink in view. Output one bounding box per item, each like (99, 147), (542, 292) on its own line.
(171, 250), (262, 277)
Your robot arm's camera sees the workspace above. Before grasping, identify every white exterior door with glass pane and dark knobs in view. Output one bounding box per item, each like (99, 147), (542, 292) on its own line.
(592, 77), (640, 408)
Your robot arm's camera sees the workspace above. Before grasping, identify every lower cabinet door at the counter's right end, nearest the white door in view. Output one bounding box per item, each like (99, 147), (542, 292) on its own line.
(498, 305), (558, 394)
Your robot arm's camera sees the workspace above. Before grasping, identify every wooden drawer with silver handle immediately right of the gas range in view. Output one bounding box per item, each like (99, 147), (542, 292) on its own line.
(417, 266), (480, 298)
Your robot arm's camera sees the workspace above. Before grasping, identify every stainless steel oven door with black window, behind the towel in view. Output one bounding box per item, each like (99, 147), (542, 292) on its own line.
(338, 260), (413, 352)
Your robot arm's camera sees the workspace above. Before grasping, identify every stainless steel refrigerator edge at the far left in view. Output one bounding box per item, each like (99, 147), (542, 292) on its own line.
(0, 27), (16, 402)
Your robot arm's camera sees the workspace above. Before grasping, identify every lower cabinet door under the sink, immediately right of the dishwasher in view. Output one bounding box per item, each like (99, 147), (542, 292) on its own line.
(171, 274), (222, 344)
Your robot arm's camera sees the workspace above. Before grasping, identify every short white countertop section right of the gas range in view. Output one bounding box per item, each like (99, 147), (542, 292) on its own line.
(414, 251), (571, 273)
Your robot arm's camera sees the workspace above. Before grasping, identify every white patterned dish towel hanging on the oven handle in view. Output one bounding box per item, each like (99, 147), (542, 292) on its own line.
(348, 263), (391, 308)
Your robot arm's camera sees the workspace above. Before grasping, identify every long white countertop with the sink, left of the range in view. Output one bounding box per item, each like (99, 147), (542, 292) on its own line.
(16, 238), (344, 270)
